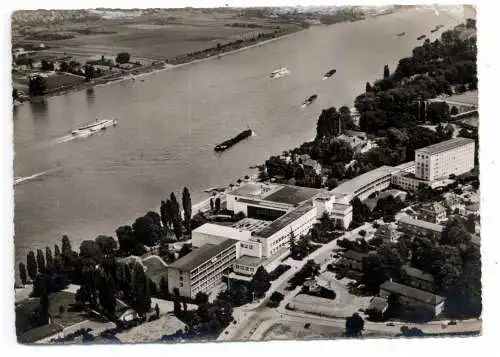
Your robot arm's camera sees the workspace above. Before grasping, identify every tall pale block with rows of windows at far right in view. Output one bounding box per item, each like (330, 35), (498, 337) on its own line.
(415, 137), (476, 181)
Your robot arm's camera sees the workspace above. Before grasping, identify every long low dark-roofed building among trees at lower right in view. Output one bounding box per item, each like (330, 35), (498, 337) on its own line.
(379, 280), (445, 317)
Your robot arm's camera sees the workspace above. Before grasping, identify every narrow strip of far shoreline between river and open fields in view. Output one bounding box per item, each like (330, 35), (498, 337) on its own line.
(22, 28), (307, 106)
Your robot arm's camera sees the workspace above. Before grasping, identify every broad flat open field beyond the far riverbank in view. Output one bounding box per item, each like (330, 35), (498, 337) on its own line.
(14, 10), (297, 60)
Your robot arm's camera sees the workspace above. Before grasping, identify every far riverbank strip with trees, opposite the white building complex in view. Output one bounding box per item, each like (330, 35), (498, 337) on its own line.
(20, 27), (306, 105)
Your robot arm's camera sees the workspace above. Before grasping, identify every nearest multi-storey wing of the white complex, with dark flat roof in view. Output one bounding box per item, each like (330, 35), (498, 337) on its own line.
(167, 239), (238, 298)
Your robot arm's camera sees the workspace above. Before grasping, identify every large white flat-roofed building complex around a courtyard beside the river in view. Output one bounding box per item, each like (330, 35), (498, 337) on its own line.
(168, 183), (352, 298)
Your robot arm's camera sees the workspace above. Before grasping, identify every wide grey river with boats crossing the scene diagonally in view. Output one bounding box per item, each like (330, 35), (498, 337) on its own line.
(14, 11), (458, 265)
